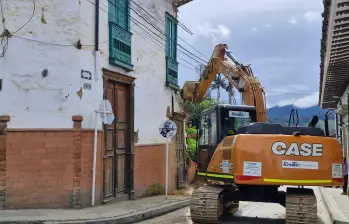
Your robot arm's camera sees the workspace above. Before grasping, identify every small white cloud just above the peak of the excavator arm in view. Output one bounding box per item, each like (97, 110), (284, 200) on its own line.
(194, 23), (231, 42)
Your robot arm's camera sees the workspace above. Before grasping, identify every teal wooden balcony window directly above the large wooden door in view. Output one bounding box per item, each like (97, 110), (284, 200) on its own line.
(108, 0), (133, 71)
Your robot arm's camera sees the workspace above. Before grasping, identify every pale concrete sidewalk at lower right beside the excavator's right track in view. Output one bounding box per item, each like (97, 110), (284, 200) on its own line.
(320, 187), (349, 224)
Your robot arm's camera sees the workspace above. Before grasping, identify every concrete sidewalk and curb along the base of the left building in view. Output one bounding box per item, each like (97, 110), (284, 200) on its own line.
(0, 196), (190, 224)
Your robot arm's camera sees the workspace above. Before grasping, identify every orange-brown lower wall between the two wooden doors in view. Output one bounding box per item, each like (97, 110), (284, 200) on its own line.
(134, 144), (177, 197)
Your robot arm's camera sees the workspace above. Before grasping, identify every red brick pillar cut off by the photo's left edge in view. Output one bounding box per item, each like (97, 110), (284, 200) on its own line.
(0, 116), (10, 210)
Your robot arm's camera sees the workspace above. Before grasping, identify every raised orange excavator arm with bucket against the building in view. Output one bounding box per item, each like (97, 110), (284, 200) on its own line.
(182, 44), (266, 123)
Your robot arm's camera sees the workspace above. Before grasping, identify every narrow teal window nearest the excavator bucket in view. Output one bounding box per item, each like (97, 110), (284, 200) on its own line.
(166, 13), (179, 89)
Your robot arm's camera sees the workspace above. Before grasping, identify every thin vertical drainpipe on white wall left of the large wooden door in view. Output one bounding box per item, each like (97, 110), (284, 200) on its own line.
(91, 0), (99, 206)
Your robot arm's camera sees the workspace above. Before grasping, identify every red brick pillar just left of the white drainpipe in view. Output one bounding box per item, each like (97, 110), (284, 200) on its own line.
(71, 115), (83, 208)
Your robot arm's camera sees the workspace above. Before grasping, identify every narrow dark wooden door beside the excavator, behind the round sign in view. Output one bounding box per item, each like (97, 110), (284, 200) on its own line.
(174, 120), (186, 188)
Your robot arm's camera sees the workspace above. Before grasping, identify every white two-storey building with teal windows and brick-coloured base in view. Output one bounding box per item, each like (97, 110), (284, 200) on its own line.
(0, 0), (193, 207)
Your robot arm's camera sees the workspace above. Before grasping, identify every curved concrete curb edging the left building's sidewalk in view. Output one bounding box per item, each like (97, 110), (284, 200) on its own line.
(0, 199), (190, 224)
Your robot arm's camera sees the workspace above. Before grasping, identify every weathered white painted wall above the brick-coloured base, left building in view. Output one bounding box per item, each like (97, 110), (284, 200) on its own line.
(0, 0), (181, 144)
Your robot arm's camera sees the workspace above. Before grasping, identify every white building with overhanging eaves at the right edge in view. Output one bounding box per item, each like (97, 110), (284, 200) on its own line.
(319, 0), (349, 163)
